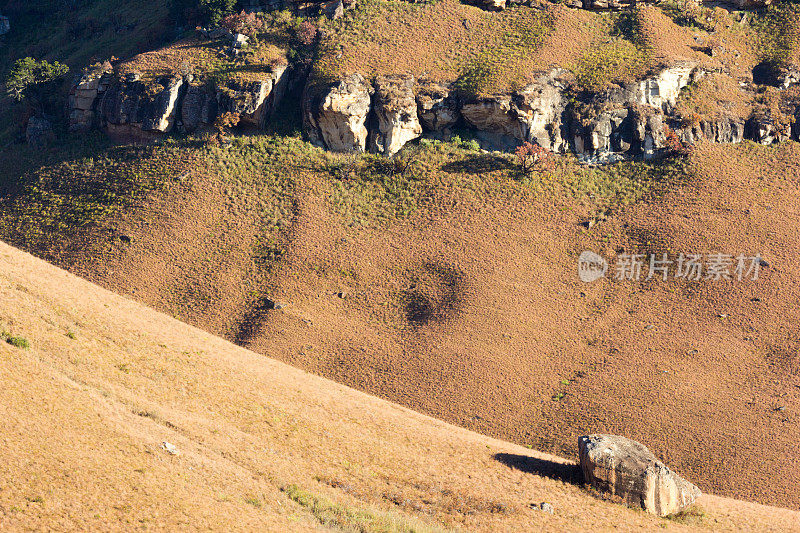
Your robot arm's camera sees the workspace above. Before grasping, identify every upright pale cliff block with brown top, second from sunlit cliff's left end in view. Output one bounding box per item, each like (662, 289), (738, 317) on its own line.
(370, 76), (422, 155)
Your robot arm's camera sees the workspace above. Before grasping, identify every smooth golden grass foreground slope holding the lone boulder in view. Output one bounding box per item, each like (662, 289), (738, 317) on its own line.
(0, 239), (798, 532)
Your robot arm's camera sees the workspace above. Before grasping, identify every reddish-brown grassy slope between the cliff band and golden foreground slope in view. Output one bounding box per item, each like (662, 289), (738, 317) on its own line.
(3, 122), (800, 507)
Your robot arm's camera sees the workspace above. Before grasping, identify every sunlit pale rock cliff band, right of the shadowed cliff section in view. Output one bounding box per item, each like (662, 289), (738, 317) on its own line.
(303, 62), (800, 163)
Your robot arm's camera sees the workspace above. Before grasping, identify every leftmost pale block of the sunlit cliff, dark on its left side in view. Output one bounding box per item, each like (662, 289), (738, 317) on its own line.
(303, 74), (373, 152)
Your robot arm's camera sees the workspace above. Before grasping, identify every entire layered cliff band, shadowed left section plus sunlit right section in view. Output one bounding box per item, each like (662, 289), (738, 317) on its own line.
(69, 55), (800, 163)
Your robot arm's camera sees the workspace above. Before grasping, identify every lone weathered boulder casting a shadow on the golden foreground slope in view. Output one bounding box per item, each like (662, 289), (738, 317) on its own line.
(578, 435), (700, 516)
